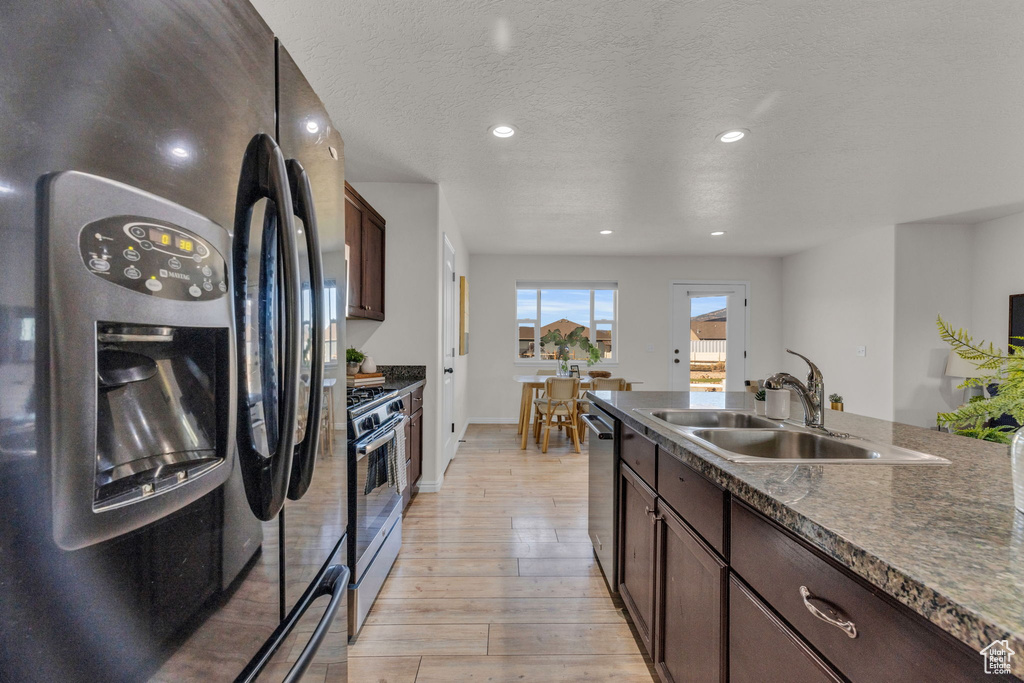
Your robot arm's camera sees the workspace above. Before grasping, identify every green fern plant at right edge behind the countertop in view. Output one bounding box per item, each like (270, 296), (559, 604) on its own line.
(936, 315), (1024, 443)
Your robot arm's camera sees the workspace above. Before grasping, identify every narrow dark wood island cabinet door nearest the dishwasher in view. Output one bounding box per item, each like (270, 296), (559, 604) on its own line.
(618, 464), (657, 653)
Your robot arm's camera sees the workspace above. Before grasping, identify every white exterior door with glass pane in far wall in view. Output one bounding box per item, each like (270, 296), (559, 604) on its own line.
(670, 283), (748, 391)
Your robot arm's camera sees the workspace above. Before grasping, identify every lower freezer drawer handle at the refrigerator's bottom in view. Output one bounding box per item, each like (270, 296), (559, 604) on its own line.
(234, 564), (349, 683)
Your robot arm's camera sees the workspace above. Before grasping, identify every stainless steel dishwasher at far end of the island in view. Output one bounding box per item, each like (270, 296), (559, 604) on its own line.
(583, 402), (618, 593)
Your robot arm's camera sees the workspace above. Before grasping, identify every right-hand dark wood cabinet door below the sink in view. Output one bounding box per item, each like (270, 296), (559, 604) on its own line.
(654, 502), (729, 683)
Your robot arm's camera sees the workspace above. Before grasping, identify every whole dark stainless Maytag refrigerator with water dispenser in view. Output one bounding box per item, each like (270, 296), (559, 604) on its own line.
(0, 0), (348, 681)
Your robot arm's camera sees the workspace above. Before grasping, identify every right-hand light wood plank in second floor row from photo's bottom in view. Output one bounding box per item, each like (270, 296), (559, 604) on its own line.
(487, 622), (637, 655)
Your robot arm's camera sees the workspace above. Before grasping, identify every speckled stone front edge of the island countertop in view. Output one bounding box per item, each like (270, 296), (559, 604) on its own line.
(588, 391), (1024, 677)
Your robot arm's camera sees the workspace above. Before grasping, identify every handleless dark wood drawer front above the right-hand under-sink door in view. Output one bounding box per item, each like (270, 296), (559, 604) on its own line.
(657, 453), (729, 557)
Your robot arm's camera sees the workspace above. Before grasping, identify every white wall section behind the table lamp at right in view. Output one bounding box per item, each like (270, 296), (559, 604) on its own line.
(893, 224), (970, 427)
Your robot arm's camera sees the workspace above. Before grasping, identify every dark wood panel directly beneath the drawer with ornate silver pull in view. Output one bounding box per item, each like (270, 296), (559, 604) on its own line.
(729, 575), (843, 683)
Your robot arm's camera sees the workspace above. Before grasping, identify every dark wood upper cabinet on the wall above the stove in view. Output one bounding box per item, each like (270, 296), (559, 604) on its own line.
(345, 182), (384, 321)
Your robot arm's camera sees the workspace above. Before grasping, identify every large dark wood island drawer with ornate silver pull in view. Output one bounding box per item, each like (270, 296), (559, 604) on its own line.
(730, 500), (994, 683)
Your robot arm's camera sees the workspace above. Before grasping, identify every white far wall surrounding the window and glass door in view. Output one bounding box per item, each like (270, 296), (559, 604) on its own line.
(468, 254), (782, 422)
